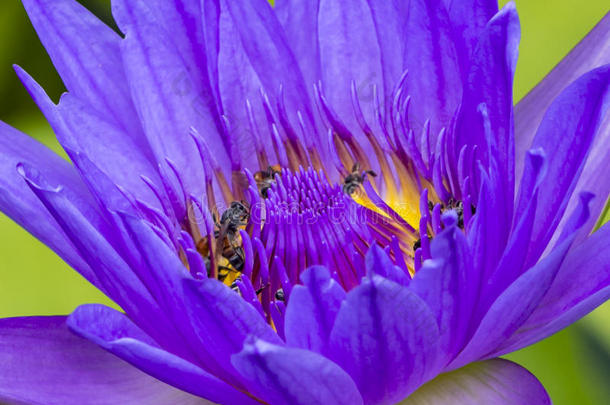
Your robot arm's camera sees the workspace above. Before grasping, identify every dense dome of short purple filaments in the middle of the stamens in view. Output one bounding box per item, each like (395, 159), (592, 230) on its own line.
(260, 169), (377, 289)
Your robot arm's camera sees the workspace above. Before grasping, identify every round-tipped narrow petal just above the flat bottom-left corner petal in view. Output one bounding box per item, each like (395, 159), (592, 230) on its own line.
(67, 304), (253, 404)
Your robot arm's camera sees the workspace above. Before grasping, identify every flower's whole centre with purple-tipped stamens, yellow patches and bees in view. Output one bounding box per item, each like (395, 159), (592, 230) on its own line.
(147, 76), (478, 325)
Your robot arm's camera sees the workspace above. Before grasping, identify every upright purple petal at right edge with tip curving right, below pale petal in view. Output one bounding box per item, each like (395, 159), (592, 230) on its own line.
(515, 66), (610, 266)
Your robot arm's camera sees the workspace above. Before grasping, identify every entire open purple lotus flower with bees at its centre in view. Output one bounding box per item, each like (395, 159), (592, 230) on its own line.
(0, 0), (610, 405)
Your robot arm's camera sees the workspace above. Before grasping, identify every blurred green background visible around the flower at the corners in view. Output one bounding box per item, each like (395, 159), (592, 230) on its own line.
(0, 0), (610, 405)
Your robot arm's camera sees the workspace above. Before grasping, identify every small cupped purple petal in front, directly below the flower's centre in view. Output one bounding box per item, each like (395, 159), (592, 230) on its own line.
(284, 266), (345, 353)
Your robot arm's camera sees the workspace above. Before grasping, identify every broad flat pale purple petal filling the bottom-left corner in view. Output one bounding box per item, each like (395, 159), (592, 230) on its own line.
(0, 316), (209, 405)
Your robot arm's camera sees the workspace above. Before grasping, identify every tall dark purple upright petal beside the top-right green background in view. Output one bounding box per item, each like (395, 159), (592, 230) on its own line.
(455, 3), (520, 251)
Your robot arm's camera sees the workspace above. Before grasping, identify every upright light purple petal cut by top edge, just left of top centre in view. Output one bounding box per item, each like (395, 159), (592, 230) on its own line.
(204, 0), (324, 169)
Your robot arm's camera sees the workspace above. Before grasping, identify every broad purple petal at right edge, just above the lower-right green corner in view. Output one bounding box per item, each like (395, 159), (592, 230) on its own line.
(497, 219), (610, 354)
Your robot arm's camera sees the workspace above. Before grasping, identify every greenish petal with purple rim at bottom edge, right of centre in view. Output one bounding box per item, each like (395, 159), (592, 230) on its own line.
(400, 359), (551, 405)
